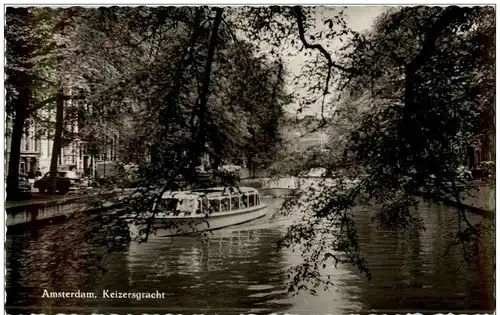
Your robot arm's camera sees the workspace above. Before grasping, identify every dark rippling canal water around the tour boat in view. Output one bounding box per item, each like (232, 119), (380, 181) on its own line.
(6, 198), (495, 314)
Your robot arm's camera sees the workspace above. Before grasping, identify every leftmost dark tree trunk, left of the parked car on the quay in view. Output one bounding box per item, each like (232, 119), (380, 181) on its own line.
(7, 108), (27, 200)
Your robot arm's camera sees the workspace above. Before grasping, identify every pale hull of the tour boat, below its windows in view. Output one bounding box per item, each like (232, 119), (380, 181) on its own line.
(130, 204), (267, 240)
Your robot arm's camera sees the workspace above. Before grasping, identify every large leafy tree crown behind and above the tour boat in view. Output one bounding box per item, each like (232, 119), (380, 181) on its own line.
(74, 8), (287, 178)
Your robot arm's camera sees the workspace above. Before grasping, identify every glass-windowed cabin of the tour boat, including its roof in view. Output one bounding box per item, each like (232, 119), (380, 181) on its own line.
(156, 187), (261, 217)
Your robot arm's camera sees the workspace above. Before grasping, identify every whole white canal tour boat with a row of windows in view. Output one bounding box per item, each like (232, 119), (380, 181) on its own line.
(130, 187), (267, 239)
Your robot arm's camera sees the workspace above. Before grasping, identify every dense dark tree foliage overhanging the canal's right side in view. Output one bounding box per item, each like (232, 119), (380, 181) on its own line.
(285, 7), (494, 294)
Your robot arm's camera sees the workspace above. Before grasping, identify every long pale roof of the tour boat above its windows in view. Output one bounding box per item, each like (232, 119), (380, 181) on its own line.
(162, 187), (259, 199)
